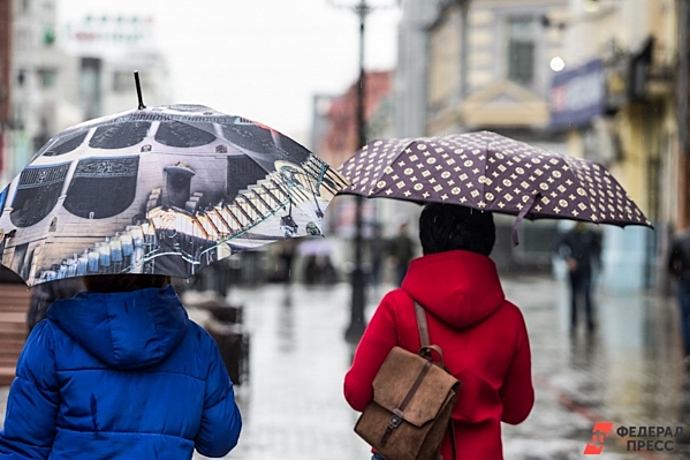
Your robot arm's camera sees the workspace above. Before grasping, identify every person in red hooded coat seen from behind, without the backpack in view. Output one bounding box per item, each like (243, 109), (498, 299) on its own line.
(344, 204), (534, 460)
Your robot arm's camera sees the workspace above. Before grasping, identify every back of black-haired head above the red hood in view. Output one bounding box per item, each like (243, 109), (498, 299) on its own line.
(419, 203), (496, 256)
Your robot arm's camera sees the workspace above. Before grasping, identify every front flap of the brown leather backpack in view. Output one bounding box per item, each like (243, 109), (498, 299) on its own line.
(373, 346), (460, 427)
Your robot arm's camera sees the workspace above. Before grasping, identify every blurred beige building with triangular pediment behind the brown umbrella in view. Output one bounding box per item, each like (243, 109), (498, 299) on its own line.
(426, 0), (568, 270)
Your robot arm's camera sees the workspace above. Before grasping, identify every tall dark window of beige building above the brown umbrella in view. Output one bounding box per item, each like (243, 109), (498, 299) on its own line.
(507, 17), (537, 86)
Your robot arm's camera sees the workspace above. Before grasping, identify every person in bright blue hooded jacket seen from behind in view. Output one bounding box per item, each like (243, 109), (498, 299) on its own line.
(0, 275), (242, 460)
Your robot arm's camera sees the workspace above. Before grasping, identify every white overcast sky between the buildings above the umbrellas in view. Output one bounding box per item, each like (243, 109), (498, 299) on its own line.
(58, 0), (400, 141)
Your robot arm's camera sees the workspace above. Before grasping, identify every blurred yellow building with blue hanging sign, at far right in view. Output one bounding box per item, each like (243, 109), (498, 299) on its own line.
(550, 0), (680, 290)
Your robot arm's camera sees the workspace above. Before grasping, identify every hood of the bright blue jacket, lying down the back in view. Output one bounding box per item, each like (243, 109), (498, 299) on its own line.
(48, 286), (189, 369)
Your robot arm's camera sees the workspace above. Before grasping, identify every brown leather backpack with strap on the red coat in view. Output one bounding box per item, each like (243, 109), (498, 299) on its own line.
(355, 302), (460, 460)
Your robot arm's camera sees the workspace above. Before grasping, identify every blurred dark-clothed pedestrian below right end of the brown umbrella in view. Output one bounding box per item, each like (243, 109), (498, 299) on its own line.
(558, 222), (602, 333)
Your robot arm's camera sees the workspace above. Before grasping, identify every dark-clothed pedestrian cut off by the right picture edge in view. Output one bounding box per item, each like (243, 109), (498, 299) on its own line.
(667, 229), (690, 368)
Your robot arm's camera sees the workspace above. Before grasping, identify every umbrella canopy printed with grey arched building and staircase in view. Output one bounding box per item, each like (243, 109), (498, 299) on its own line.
(0, 105), (347, 286)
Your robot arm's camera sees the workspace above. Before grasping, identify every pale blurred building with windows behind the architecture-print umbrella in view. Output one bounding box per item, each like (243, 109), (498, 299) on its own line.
(0, 4), (172, 185)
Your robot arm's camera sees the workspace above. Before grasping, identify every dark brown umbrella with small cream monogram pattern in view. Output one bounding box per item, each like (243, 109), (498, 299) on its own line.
(339, 131), (651, 244)
